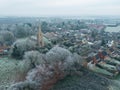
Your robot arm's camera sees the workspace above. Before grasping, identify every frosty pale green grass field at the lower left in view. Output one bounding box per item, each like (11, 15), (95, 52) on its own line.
(0, 57), (22, 90)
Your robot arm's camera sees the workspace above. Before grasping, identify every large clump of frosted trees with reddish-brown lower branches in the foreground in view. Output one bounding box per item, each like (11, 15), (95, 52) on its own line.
(8, 46), (81, 90)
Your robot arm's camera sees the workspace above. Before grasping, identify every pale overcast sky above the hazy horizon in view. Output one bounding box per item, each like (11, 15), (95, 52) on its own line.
(0, 0), (120, 16)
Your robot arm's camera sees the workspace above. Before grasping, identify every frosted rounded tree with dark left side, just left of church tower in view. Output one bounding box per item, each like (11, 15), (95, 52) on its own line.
(11, 38), (36, 58)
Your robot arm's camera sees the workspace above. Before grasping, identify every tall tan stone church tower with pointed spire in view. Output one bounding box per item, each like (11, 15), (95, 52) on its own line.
(37, 26), (44, 47)
